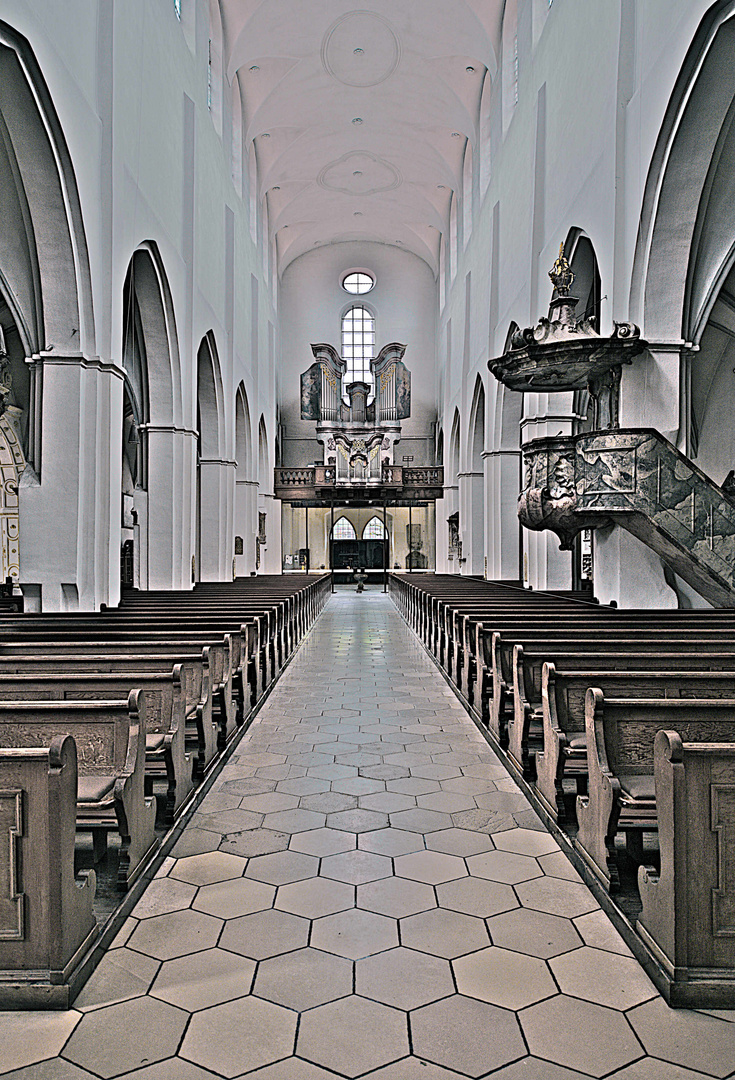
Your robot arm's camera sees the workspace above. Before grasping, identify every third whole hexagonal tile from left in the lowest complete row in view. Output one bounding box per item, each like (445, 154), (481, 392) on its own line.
(296, 996), (408, 1077)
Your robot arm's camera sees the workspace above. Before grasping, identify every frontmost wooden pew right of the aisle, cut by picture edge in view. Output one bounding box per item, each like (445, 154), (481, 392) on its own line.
(636, 730), (735, 1009)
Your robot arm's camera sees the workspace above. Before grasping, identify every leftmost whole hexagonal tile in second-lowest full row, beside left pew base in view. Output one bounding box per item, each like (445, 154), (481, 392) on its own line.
(150, 948), (255, 1012)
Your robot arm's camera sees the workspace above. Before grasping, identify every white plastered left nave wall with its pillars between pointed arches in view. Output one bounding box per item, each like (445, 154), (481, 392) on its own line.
(0, 0), (280, 608)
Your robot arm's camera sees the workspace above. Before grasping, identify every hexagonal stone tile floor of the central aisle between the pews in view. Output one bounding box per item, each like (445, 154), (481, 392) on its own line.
(0, 591), (735, 1080)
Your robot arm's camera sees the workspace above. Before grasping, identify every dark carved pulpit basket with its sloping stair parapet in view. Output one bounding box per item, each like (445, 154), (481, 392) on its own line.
(518, 428), (735, 607)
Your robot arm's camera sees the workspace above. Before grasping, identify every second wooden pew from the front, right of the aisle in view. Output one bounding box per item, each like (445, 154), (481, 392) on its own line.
(575, 687), (735, 891)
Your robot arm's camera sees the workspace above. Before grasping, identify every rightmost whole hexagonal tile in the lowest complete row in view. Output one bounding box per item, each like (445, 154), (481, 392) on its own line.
(519, 994), (643, 1077)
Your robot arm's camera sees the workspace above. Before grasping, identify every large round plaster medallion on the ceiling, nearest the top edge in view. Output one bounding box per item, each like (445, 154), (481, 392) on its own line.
(322, 11), (400, 86)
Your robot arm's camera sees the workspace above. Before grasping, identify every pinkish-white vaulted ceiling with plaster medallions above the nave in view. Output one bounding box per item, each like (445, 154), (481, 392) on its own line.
(220, 0), (504, 272)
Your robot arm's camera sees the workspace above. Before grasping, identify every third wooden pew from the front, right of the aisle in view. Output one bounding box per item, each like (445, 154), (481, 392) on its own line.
(529, 657), (735, 823)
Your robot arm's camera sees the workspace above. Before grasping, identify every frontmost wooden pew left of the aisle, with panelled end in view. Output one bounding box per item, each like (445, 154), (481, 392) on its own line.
(0, 734), (97, 1009)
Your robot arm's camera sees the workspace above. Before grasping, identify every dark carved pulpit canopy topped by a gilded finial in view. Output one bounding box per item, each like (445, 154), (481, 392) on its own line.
(488, 244), (648, 429)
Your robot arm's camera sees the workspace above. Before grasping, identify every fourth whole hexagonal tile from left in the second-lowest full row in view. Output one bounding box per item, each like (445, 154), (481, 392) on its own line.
(452, 946), (557, 1011)
